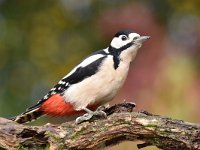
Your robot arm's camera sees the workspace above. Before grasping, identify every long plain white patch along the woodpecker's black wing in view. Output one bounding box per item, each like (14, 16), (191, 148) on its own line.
(63, 54), (105, 79)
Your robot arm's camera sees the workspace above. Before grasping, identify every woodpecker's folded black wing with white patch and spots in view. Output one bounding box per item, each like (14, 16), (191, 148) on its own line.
(27, 51), (106, 111)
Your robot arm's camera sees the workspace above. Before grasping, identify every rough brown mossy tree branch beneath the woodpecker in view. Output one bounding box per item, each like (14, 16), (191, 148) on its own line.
(0, 103), (200, 150)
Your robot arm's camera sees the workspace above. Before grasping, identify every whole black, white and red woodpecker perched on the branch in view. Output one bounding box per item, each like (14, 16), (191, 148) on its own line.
(12, 30), (150, 123)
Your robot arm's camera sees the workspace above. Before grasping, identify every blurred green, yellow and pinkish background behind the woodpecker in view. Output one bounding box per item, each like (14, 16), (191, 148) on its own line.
(0, 0), (200, 150)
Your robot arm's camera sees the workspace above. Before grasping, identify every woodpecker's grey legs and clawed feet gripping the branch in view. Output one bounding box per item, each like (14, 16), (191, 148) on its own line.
(76, 106), (107, 124)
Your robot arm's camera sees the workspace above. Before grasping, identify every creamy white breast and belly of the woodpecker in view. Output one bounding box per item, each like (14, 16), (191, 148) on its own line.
(64, 55), (130, 110)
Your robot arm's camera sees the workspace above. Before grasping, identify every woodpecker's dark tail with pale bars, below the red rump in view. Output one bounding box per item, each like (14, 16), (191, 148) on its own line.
(10, 106), (44, 124)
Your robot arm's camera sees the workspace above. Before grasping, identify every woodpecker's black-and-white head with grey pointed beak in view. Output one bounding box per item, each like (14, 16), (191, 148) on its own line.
(109, 30), (150, 61)
